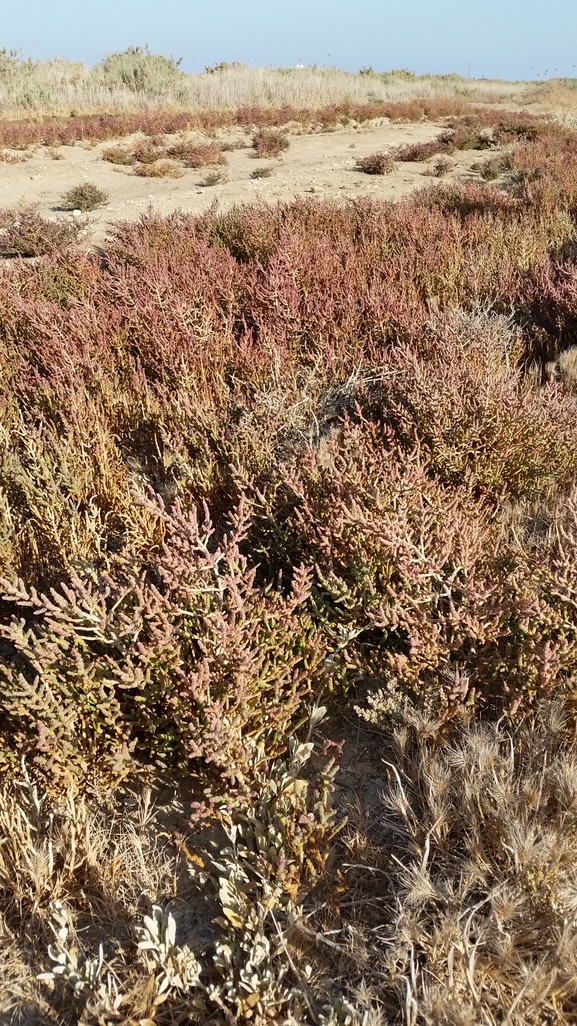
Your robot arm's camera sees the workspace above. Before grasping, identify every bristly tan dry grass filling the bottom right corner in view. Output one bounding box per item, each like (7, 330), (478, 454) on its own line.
(308, 695), (577, 1026)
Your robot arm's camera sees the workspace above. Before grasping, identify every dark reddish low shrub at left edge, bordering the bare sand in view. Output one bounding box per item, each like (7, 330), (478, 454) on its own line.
(0, 204), (85, 257)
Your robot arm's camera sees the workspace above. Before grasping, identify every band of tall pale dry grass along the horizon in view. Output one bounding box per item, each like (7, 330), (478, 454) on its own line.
(0, 51), (531, 117)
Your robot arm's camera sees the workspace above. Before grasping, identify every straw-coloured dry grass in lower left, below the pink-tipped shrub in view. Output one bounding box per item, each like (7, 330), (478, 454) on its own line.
(0, 770), (197, 1026)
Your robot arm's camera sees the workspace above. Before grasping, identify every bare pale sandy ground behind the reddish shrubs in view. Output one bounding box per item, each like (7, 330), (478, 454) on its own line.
(0, 122), (494, 244)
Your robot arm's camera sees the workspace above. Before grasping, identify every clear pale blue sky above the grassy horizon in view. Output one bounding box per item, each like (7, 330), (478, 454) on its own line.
(0, 0), (577, 79)
